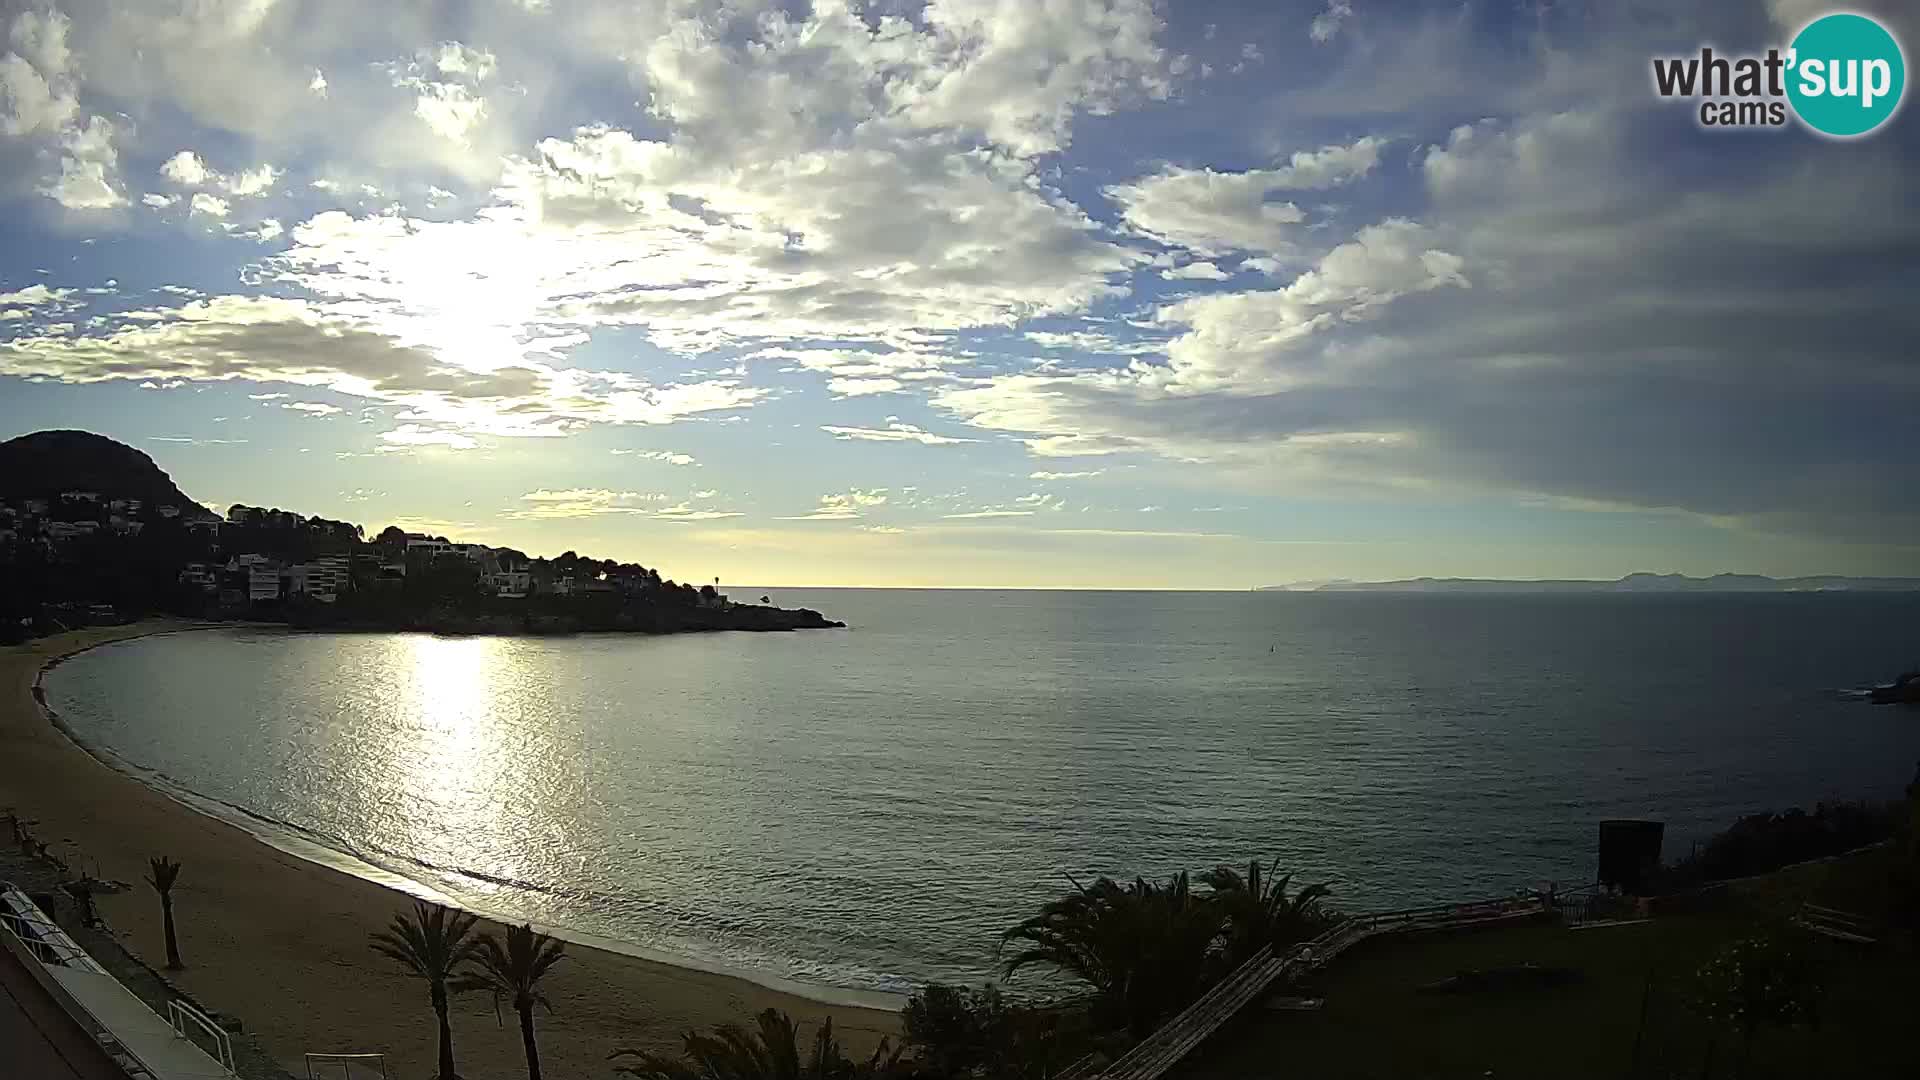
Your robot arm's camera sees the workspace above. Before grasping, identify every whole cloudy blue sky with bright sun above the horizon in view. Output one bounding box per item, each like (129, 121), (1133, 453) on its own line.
(0, 0), (1920, 588)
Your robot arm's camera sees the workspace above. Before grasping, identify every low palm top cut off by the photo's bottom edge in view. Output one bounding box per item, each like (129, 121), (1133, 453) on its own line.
(609, 1009), (900, 1080)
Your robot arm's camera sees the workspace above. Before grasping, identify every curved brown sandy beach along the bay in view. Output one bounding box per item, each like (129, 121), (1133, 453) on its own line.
(0, 623), (899, 1080)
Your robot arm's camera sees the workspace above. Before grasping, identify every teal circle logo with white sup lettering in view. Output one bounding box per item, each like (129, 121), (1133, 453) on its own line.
(1788, 12), (1907, 138)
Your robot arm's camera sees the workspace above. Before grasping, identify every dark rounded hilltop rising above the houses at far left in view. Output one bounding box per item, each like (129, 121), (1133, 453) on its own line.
(0, 430), (215, 517)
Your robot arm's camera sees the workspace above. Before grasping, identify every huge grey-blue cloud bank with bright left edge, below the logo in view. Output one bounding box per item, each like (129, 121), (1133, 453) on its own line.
(935, 110), (1920, 544)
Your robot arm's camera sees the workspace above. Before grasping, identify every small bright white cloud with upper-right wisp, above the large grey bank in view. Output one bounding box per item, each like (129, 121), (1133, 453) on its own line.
(1104, 136), (1386, 256)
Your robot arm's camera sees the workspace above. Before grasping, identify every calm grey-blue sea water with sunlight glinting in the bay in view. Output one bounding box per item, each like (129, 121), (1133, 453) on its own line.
(48, 588), (1920, 990)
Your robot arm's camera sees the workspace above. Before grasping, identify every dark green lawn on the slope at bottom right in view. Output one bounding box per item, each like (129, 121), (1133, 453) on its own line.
(1175, 851), (1920, 1080)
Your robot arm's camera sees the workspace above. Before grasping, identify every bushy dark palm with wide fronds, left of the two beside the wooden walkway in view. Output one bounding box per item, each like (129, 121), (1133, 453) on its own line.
(1000, 872), (1221, 1034)
